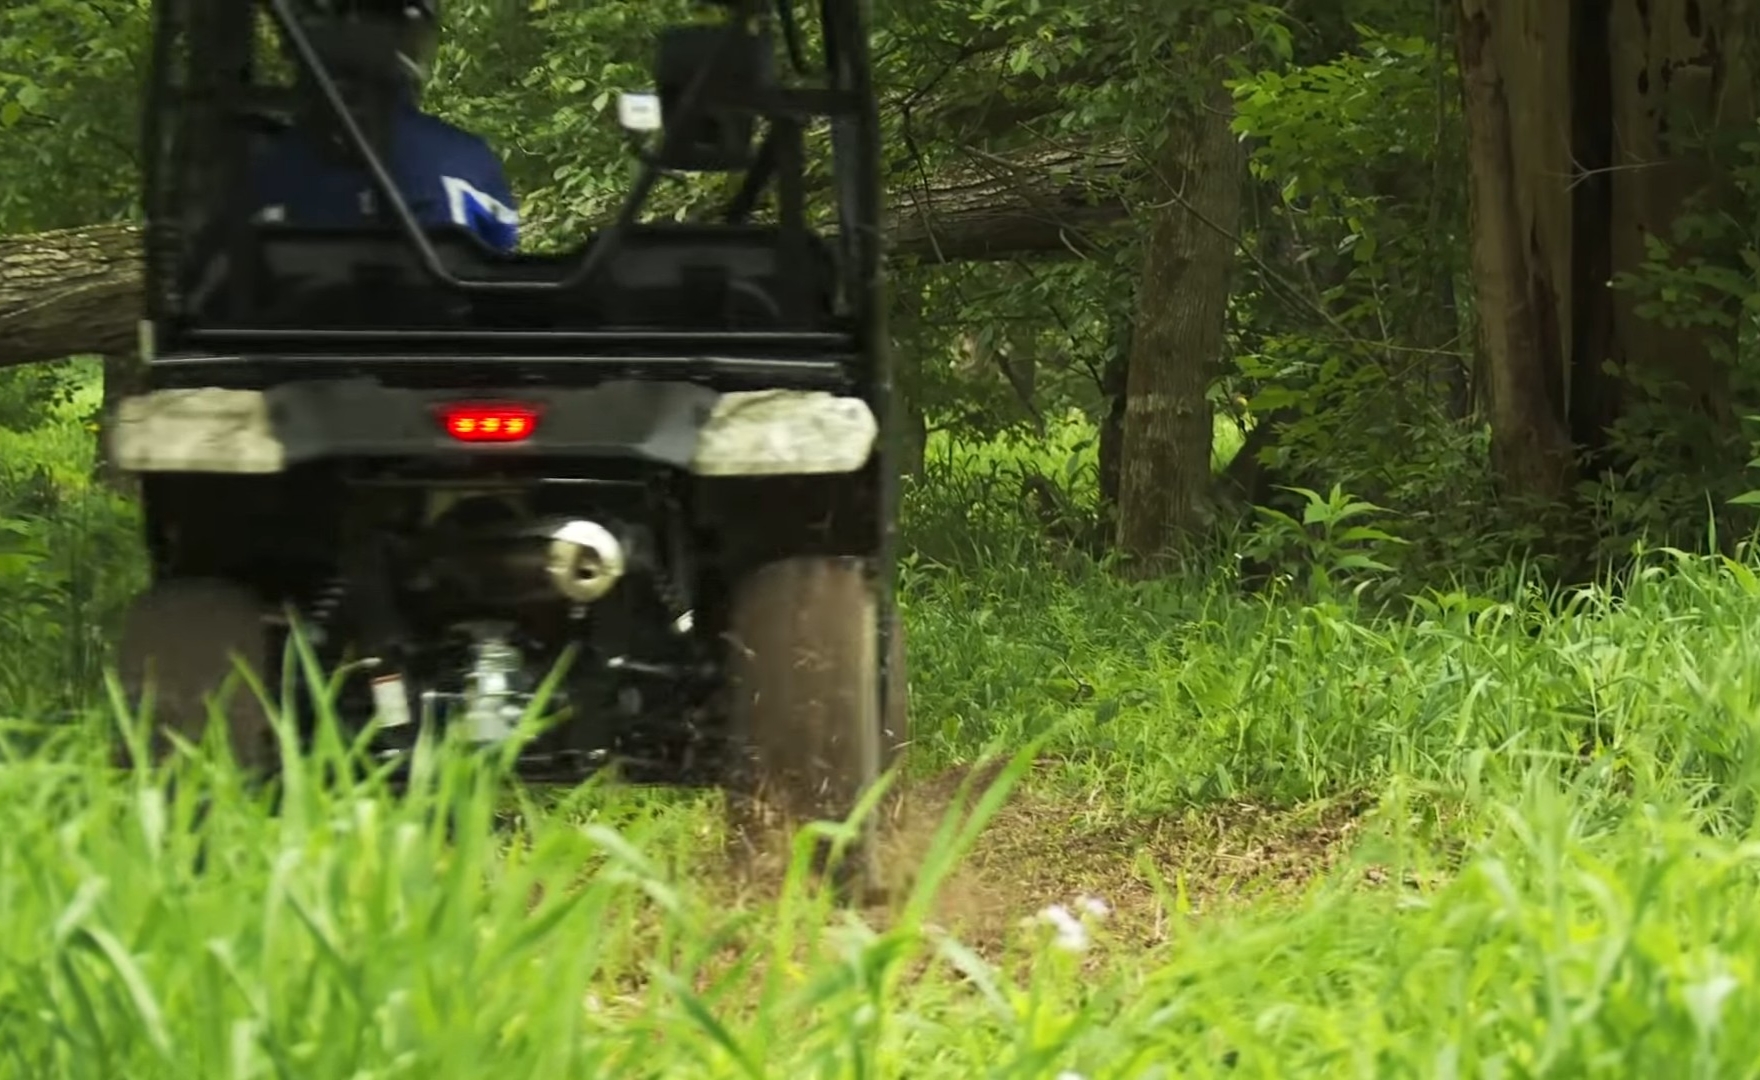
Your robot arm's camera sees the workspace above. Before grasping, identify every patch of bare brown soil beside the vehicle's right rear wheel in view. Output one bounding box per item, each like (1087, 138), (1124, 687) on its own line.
(563, 763), (1378, 1008)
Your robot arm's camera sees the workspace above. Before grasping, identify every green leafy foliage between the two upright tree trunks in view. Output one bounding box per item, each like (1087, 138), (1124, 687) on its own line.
(1230, 26), (1513, 580)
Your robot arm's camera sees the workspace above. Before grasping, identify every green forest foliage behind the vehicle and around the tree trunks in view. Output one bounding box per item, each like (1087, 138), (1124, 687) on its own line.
(0, 0), (1760, 582)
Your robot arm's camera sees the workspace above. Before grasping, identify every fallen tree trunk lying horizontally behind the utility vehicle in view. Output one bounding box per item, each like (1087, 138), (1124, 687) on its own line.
(0, 151), (1126, 368)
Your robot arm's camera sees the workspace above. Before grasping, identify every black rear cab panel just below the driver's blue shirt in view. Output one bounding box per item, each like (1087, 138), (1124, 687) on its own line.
(182, 225), (852, 350)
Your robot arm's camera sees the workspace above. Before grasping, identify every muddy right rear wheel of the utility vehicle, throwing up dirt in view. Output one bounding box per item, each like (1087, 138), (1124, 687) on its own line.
(729, 558), (889, 895)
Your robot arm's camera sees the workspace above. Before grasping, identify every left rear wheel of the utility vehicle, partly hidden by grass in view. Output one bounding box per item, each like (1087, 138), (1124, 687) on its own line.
(116, 579), (276, 774)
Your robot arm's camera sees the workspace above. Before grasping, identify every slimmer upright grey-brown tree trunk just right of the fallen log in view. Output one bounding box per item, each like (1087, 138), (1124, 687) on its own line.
(1118, 63), (1246, 572)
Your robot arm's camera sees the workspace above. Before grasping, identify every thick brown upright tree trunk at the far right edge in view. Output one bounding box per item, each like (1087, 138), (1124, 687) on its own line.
(1457, 0), (1755, 498)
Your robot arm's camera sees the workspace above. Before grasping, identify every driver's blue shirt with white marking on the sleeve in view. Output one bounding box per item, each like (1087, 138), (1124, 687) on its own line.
(255, 106), (519, 252)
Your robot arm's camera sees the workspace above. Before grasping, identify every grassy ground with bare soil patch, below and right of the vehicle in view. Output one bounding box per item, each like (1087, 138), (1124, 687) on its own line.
(10, 559), (1760, 1080)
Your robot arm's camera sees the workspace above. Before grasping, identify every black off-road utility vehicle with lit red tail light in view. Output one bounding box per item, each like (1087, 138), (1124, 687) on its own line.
(111, 0), (905, 890)
